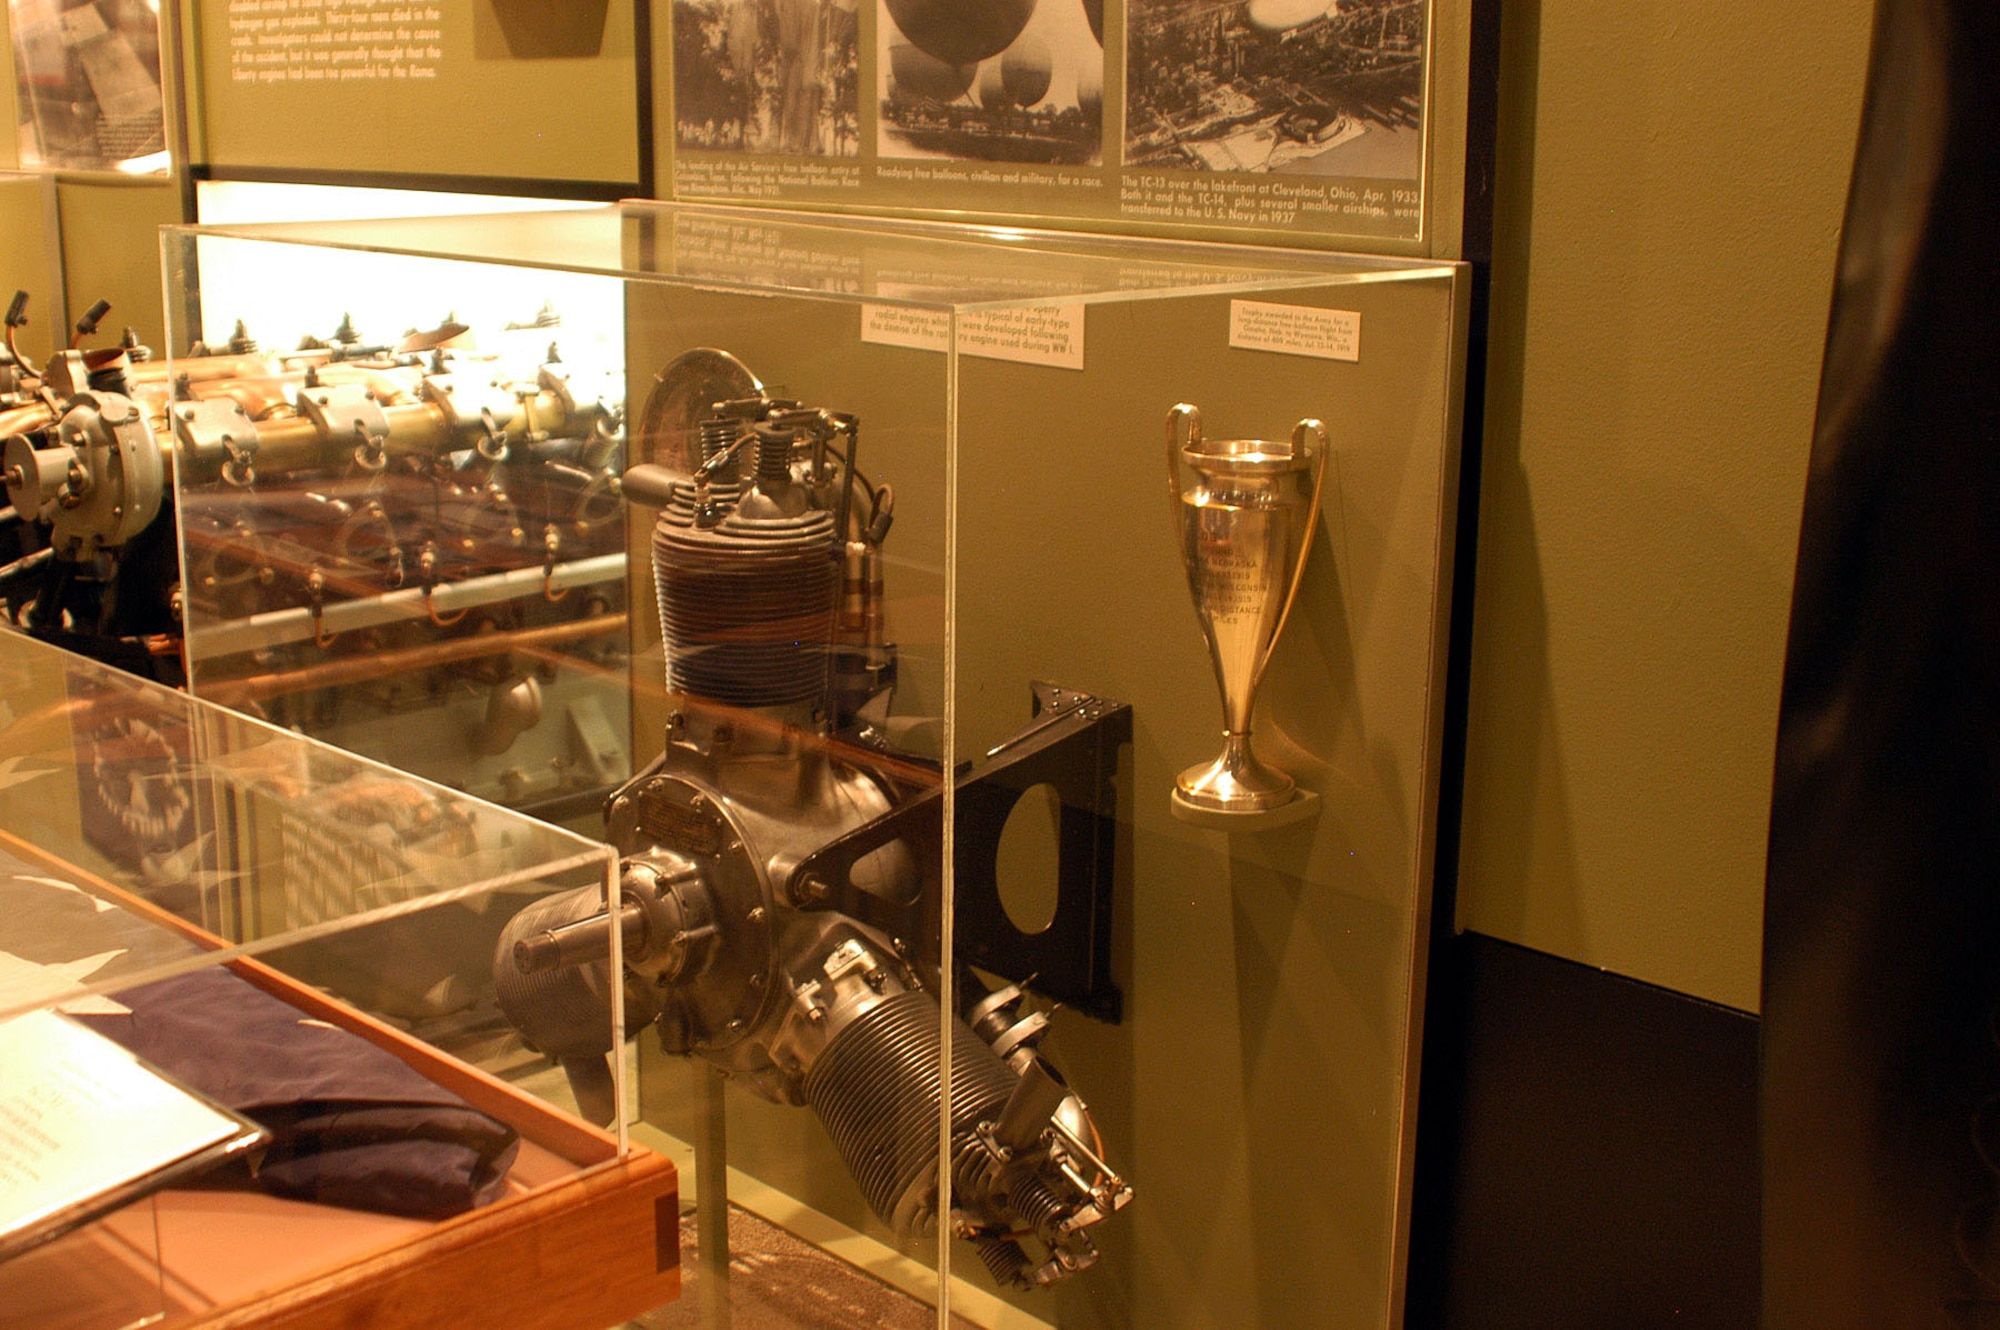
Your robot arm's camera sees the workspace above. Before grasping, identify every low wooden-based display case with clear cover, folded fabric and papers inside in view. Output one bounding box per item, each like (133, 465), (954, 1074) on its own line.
(0, 632), (678, 1330)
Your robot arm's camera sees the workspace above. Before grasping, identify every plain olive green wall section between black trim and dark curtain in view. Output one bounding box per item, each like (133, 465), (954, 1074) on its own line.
(1458, 0), (1872, 1010)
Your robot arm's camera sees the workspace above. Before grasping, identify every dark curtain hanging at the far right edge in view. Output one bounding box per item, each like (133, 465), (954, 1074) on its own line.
(1768, 0), (2000, 1330)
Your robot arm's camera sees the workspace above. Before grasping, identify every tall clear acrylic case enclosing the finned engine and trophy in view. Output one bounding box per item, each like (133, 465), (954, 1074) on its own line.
(160, 204), (1466, 1326)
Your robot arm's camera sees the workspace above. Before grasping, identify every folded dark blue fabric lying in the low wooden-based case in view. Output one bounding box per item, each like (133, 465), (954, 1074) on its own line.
(78, 970), (520, 1218)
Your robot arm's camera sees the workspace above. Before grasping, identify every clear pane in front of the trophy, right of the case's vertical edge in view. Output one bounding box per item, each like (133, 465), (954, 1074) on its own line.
(952, 260), (1458, 1326)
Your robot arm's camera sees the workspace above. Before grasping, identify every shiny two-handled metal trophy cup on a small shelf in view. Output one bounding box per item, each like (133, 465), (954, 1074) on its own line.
(1166, 402), (1328, 824)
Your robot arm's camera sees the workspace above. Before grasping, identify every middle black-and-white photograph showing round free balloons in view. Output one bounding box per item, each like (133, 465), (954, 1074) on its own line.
(878, 0), (1104, 166)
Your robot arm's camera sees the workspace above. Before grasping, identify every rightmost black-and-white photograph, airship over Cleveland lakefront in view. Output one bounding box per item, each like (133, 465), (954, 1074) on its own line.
(1124, 0), (1428, 180)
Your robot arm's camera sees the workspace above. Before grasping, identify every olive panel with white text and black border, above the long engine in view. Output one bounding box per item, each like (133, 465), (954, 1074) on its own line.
(192, 0), (640, 192)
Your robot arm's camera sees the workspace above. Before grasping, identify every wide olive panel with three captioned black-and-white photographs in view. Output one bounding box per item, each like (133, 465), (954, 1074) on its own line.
(652, 0), (1468, 256)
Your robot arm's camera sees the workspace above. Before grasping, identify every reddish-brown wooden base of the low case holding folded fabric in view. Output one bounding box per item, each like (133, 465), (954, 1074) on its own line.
(0, 832), (680, 1330)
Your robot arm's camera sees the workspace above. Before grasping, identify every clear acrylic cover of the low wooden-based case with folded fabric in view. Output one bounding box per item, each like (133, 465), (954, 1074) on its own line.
(0, 632), (656, 1326)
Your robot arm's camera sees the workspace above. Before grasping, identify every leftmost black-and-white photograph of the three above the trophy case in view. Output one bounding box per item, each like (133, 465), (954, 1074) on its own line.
(674, 0), (860, 156)
